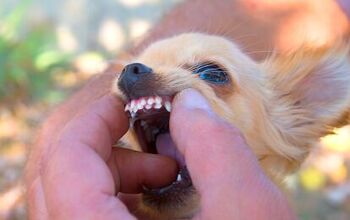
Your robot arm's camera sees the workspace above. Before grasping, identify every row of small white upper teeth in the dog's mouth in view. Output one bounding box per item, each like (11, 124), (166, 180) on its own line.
(124, 96), (171, 117)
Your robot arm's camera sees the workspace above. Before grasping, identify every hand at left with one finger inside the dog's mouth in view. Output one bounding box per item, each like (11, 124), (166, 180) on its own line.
(28, 96), (177, 219)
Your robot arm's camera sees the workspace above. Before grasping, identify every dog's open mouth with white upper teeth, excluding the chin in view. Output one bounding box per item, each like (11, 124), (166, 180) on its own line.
(125, 96), (192, 196)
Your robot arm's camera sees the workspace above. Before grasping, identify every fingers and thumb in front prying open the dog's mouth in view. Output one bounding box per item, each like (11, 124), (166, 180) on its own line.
(29, 90), (293, 219)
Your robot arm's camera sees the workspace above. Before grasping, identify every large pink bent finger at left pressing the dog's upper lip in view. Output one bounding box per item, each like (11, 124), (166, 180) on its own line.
(41, 96), (133, 219)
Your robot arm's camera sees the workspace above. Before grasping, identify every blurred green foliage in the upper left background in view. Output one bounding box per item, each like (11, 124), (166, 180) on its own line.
(0, 1), (70, 105)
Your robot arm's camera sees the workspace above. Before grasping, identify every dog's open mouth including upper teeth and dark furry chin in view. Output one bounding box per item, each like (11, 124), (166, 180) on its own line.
(125, 96), (199, 218)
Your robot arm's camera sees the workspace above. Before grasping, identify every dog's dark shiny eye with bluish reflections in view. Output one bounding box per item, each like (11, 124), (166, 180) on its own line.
(193, 63), (229, 84)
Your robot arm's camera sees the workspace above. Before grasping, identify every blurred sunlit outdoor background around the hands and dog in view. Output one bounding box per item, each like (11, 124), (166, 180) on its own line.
(0, 0), (350, 220)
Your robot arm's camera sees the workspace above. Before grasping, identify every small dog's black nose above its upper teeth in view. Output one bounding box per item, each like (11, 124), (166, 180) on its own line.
(118, 63), (153, 97)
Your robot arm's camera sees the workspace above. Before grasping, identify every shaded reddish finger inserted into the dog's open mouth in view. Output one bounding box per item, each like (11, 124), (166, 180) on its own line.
(108, 148), (178, 193)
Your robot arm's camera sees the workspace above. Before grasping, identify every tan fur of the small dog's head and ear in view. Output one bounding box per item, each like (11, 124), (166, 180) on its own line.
(114, 33), (350, 218)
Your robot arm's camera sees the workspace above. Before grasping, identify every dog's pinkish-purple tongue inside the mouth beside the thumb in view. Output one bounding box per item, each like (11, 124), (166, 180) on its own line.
(156, 133), (185, 167)
